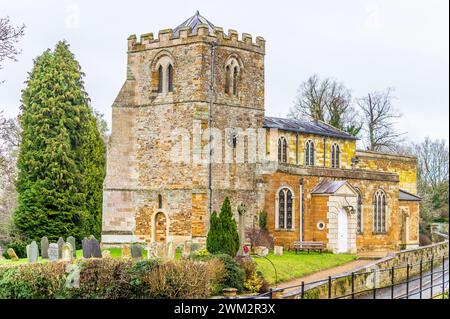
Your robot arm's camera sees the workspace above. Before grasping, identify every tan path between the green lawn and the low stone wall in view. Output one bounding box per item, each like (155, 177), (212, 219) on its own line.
(272, 259), (374, 290)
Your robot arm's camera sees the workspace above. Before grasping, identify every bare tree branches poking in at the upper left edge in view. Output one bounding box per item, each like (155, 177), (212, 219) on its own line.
(0, 17), (25, 69)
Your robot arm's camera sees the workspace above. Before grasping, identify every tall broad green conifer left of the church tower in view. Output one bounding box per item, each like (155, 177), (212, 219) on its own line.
(14, 42), (105, 240)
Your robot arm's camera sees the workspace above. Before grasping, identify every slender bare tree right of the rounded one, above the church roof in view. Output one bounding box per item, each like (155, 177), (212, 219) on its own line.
(356, 88), (403, 151)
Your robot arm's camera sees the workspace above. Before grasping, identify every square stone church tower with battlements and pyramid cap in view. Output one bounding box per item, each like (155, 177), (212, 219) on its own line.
(102, 12), (265, 246)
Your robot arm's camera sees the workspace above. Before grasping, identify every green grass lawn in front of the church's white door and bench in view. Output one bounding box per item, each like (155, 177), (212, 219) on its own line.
(253, 251), (356, 284)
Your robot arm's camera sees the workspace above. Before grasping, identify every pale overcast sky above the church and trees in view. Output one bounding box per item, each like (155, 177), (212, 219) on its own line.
(0, 0), (449, 142)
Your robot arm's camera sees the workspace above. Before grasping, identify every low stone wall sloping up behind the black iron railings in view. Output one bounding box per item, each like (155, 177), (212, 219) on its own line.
(284, 241), (449, 299)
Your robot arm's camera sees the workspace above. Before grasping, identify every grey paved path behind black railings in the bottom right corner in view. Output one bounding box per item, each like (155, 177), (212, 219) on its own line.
(356, 259), (449, 299)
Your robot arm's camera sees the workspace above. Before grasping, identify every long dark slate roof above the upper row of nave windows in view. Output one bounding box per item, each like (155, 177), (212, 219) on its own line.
(264, 116), (358, 140)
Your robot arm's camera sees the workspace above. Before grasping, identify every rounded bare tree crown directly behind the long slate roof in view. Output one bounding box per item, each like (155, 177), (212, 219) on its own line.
(288, 75), (360, 135)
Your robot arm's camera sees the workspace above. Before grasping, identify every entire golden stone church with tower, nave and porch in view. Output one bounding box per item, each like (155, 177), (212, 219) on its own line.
(102, 12), (420, 253)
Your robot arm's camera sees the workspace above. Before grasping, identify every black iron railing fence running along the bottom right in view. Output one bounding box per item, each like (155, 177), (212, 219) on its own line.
(245, 256), (449, 299)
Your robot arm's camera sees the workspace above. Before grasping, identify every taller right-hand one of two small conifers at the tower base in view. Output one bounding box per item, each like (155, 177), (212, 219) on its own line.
(219, 197), (239, 257)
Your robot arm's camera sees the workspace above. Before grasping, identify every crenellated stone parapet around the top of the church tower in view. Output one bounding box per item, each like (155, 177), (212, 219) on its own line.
(128, 24), (266, 54)
